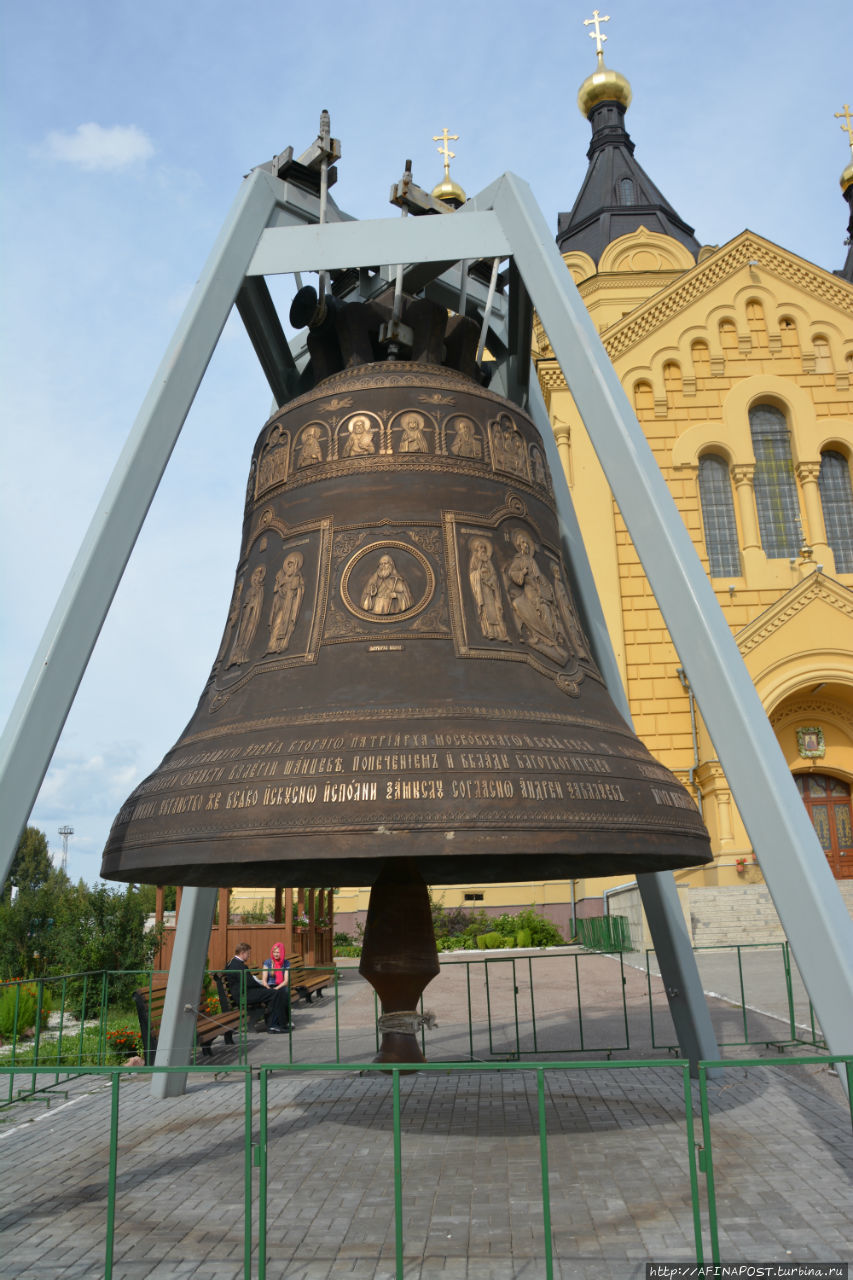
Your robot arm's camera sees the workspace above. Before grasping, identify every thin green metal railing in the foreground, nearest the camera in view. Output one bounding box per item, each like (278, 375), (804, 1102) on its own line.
(0, 1055), (853, 1280)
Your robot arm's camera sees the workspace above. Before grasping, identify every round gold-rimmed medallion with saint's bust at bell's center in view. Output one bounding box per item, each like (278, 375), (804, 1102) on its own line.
(341, 539), (435, 626)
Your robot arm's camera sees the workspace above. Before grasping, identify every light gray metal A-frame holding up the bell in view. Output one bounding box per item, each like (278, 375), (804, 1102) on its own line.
(0, 170), (853, 1092)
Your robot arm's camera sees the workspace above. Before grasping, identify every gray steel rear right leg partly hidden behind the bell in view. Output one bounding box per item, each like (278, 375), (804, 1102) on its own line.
(530, 371), (720, 1075)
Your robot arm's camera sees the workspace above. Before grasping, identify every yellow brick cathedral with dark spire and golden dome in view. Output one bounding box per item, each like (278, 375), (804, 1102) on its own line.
(233, 42), (853, 945)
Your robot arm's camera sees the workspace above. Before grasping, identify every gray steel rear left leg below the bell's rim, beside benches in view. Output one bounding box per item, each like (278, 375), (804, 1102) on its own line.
(151, 888), (217, 1098)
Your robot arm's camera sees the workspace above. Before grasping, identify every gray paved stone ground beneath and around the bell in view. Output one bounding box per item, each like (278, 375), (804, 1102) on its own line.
(0, 957), (853, 1280)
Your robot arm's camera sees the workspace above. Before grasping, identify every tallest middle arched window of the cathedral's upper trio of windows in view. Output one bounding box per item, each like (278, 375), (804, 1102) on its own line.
(749, 404), (802, 559)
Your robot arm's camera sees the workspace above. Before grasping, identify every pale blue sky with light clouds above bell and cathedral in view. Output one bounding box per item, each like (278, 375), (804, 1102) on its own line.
(0, 0), (853, 882)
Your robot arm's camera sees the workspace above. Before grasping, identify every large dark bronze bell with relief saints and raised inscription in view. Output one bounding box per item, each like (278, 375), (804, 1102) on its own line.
(102, 294), (711, 1059)
